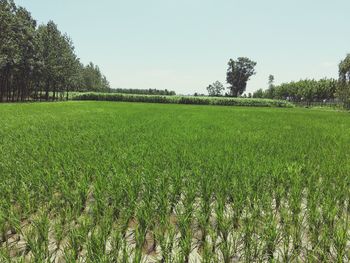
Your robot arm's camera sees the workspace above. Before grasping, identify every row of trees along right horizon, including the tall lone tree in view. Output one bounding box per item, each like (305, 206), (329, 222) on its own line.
(207, 54), (350, 106)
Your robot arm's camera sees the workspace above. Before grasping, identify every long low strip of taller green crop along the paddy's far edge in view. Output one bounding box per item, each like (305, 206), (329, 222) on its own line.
(72, 93), (294, 107)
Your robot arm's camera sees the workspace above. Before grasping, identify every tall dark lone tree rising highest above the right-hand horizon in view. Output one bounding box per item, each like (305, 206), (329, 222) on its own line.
(226, 57), (257, 97)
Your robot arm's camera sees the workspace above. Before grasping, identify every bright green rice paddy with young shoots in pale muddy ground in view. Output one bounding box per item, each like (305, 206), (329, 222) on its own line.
(0, 101), (350, 262)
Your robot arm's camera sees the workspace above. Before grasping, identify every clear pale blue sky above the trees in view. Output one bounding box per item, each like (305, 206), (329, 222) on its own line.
(16, 0), (350, 94)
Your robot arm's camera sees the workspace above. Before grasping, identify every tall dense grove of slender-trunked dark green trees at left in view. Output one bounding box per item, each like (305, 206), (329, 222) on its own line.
(0, 0), (110, 102)
